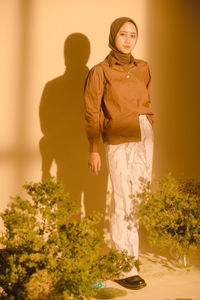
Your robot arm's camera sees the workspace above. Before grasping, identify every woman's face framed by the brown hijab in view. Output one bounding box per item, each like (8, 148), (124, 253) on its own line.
(115, 22), (137, 54)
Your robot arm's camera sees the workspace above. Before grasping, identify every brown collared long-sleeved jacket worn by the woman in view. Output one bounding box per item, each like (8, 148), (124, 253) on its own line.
(84, 55), (154, 152)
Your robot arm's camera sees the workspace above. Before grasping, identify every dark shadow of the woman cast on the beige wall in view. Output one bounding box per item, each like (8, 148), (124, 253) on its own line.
(39, 33), (107, 230)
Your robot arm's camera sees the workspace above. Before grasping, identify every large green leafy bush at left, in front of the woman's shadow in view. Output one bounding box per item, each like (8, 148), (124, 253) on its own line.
(0, 178), (134, 300)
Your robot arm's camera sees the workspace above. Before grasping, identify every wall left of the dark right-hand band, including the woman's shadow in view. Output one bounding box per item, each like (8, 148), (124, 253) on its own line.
(0, 0), (146, 232)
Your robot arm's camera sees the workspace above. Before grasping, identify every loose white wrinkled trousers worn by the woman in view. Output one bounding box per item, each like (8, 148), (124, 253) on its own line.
(105, 115), (154, 278)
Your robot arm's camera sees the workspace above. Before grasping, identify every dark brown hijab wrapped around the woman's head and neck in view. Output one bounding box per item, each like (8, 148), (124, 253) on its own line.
(108, 17), (138, 65)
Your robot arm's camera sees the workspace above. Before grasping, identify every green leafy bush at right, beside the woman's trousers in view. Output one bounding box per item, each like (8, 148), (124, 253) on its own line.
(131, 173), (200, 255)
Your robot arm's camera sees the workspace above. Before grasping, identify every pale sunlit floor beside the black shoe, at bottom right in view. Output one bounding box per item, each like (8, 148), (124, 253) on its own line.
(92, 251), (200, 300)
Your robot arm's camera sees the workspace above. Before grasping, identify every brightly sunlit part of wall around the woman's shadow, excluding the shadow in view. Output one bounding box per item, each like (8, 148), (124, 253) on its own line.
(0, 0), (146, 232)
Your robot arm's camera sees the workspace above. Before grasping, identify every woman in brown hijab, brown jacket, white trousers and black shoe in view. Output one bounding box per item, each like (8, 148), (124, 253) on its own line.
(84, 17), (154, 289)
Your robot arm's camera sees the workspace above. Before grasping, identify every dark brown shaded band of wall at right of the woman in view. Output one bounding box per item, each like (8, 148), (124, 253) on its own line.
(146, 0), (200, 179)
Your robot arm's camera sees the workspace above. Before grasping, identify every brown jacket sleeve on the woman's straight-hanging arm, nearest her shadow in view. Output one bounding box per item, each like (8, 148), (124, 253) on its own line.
(84, 65), (104, 152)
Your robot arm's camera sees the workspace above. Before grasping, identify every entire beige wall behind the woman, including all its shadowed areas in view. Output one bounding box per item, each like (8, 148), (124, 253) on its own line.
(0, 0), (200, 232)
